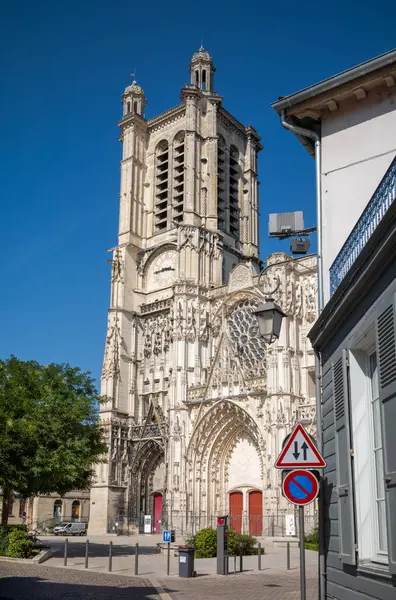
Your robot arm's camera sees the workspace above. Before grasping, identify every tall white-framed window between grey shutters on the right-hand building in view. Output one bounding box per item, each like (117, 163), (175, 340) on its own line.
(349, 340), (388, 563)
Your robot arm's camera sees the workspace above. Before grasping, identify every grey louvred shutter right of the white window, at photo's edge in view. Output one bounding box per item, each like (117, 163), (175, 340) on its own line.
(377, 302), (396, 574)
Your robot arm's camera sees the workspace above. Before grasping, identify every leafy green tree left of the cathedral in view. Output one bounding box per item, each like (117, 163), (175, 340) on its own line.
(0, 356), (107, 524)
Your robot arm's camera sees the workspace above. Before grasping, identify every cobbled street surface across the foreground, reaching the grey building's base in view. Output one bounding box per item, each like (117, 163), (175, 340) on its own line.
(0, 562), (317, 600)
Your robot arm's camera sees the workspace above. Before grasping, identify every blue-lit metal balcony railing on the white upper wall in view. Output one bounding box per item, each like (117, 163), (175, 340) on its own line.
(330, 158), (396, 294)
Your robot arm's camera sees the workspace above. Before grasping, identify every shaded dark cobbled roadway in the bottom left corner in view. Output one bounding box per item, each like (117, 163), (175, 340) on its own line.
(0, 561), (161, 600)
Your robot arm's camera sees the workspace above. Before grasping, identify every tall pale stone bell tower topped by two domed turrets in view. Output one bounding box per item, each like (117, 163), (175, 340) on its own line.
(90, 47), (261, 533)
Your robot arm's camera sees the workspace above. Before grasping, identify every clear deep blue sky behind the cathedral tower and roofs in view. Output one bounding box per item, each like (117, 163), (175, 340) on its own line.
(0, 0), (396, 378)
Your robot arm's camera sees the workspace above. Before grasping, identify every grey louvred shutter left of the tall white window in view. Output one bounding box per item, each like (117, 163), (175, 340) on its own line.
(333, 350), (356, 565)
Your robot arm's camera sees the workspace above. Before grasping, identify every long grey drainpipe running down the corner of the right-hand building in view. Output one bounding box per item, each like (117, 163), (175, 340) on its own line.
(281, 110), (326, 600)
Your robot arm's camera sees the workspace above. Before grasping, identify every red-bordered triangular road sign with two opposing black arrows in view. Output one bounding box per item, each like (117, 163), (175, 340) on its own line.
(275, 423), (326, 469)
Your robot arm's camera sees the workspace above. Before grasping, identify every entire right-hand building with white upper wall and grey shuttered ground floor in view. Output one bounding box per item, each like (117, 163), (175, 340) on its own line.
(273, 50), (396, 600)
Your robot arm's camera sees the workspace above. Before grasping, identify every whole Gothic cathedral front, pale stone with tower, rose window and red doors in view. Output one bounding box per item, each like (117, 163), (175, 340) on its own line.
(89, 47), (317, 535)
